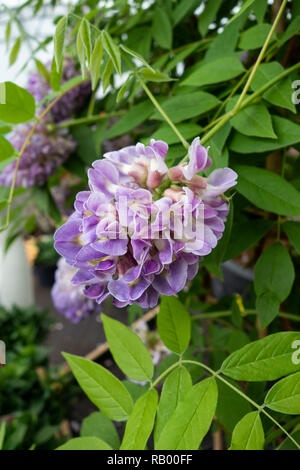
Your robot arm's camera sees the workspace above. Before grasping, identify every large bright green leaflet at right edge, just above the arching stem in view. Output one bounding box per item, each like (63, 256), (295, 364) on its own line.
(221, 331), (300, 382)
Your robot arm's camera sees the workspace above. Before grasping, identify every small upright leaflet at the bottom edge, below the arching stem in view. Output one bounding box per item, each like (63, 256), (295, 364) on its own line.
(229, 411), (265, 450)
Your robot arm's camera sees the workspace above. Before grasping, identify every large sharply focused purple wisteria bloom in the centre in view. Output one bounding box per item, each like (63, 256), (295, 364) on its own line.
(54, 138), (237, 308)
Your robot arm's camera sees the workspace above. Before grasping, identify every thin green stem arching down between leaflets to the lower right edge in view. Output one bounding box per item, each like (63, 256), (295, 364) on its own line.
(151, 358), (300, 449)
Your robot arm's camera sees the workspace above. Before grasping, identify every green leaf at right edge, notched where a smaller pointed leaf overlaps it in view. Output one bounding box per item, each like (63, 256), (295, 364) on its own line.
(230, 116), (300, 153)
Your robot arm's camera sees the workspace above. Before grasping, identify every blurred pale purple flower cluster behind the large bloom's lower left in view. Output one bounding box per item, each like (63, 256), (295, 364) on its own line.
(51, 258), (100, 323)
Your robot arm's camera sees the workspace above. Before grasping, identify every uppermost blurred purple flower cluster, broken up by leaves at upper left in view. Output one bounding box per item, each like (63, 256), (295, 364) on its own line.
(27, 57), (92, 123)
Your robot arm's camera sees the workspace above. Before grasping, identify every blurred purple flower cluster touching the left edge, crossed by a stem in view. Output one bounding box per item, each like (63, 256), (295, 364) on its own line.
(0, 123), (77, 188)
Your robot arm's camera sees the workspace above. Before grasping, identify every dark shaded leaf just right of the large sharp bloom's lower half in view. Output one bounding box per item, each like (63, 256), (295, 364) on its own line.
(223, 219), (273, 261)
